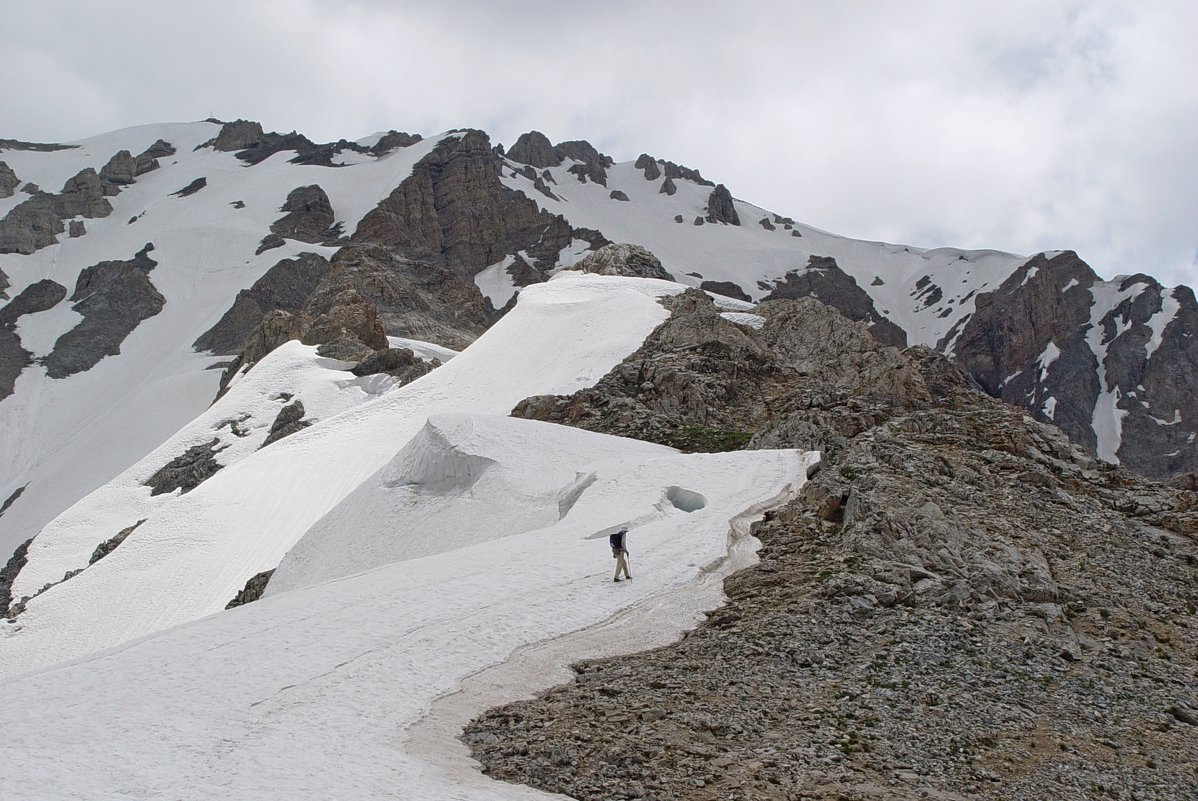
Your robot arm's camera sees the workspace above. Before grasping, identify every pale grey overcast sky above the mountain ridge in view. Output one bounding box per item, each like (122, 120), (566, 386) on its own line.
(7, 0), (1198, 285)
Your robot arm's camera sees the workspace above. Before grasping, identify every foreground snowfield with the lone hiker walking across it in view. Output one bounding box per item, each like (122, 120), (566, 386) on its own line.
(0, 411), (810, 801)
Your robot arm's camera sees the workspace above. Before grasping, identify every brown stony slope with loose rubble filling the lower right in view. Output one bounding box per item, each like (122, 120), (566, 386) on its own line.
(464, 293), (1198, 801)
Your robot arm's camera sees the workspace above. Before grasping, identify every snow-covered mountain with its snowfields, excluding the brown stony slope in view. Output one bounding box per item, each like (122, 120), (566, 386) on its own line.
(0, 115), (1198, 797)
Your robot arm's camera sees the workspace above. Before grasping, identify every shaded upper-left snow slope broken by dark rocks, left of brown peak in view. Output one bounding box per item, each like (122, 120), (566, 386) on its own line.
(0, 122), (454, 554)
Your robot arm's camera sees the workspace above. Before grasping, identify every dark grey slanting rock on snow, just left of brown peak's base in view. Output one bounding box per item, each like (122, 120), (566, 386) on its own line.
(193, 253), (329, 354)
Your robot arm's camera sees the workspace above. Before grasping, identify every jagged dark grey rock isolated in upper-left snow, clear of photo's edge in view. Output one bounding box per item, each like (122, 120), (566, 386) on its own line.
(43, 243), (165, 378)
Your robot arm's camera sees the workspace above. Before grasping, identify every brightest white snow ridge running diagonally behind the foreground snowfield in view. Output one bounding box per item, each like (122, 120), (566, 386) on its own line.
(0, 272), (684, 675)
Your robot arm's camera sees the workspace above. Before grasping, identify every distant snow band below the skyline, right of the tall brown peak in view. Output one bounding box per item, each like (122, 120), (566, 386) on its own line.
(502, 154), (1027, 346)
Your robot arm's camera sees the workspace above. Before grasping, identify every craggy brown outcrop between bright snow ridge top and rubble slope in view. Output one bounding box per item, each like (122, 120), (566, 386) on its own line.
(512, 290), (925, 451)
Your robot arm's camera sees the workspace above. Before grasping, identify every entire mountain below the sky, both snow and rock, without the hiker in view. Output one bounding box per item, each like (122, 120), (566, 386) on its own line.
(0, 120), (1198, 797)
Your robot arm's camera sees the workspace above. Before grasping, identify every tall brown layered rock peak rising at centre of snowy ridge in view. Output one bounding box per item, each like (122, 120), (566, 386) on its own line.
(352, 131), (599, 278)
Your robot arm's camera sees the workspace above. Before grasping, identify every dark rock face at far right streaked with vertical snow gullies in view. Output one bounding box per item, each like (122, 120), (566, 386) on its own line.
(943, 251), (1198, 478)
